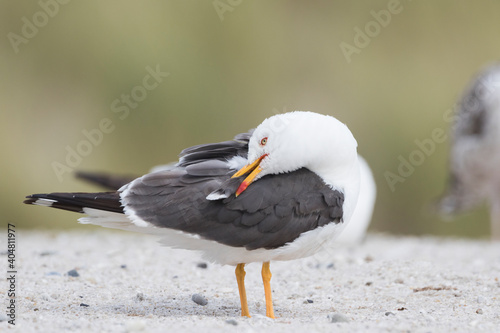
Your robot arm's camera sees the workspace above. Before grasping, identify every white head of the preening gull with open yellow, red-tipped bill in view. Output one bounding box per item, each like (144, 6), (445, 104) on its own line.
(233, 111), (359, 195)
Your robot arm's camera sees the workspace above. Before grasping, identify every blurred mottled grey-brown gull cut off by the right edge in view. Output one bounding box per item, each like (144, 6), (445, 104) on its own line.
(438, 64), (500, 240)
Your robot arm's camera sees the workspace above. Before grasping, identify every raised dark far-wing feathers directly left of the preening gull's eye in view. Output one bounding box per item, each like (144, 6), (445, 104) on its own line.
(177, 129), (254, 167)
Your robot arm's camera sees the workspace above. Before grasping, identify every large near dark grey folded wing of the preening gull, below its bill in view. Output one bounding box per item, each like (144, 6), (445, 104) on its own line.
(122, 164), (344, 250)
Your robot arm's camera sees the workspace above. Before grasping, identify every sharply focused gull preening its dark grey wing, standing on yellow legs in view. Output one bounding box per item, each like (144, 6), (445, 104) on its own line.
(24, 111), (360, 318)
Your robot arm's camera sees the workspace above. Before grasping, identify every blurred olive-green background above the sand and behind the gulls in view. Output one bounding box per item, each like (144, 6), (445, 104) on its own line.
(0, 0), (500, 237)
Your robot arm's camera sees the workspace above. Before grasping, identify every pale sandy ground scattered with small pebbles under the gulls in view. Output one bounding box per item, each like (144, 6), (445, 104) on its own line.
(0, 229), (500, 332)
